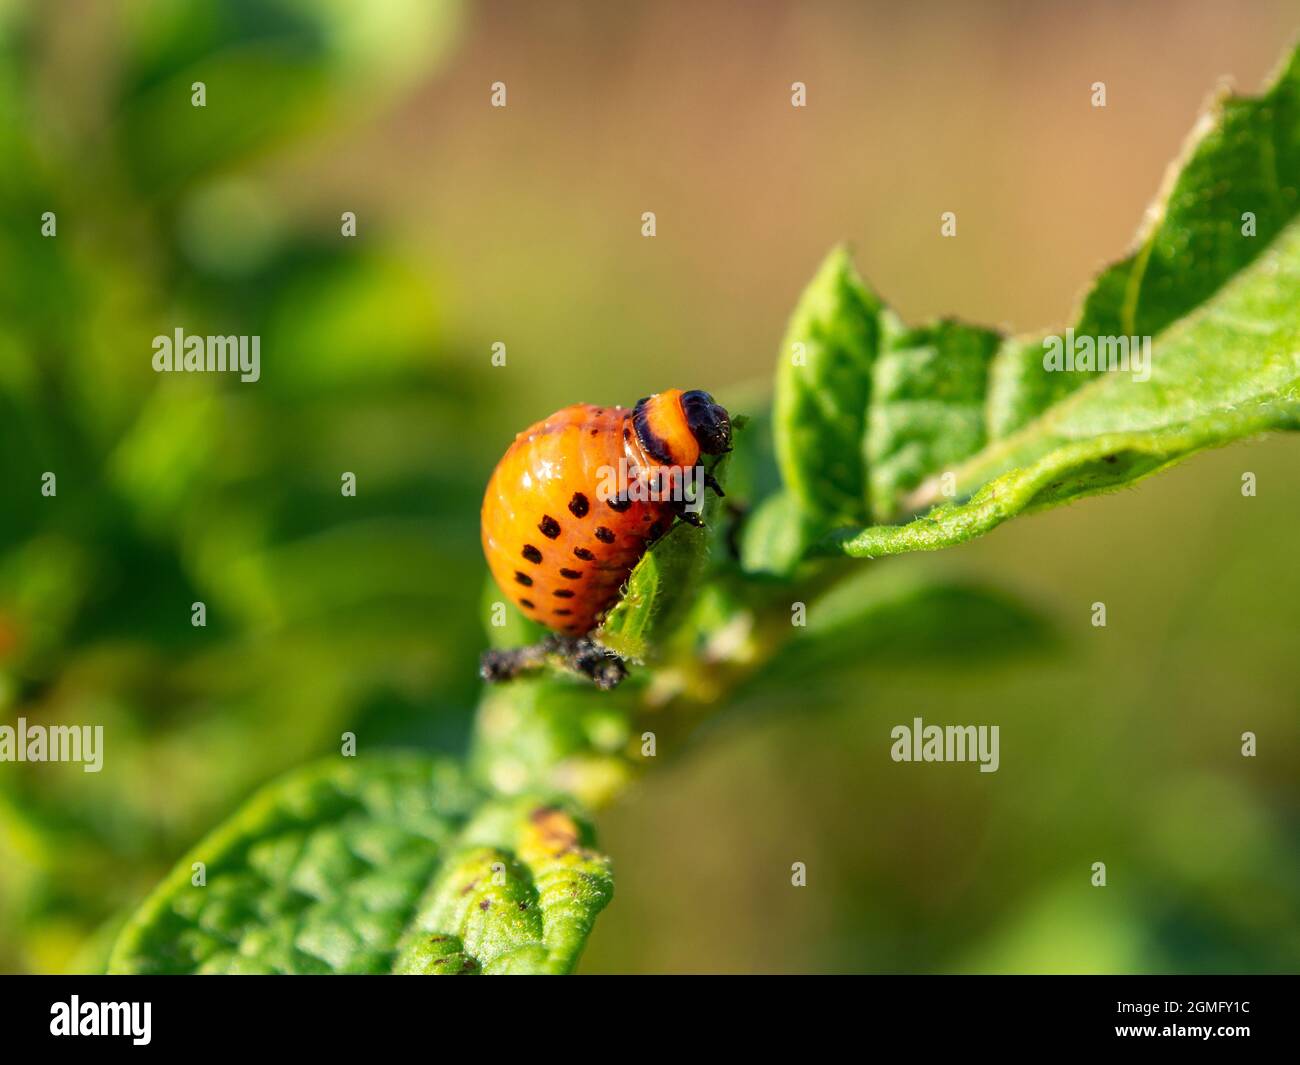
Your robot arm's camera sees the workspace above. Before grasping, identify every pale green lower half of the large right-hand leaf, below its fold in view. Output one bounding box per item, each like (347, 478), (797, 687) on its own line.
(823, 226), (1300, 558)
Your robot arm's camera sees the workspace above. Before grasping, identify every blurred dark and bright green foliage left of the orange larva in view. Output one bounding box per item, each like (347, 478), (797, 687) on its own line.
(0, 0), (470, 970)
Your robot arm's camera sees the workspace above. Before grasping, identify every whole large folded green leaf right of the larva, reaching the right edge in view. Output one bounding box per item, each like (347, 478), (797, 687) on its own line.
(769, 52), (1300, 566)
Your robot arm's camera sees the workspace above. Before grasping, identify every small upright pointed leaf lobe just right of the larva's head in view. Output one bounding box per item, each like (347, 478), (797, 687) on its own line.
(772, 248), (880, 527)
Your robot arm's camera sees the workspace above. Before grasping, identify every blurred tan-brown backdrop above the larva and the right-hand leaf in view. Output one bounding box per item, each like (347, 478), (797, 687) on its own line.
(280, 3), (1300, 400)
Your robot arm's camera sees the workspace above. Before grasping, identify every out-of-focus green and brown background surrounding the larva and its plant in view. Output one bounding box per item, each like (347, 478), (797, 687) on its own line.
(0, 0), (1300, 973)
